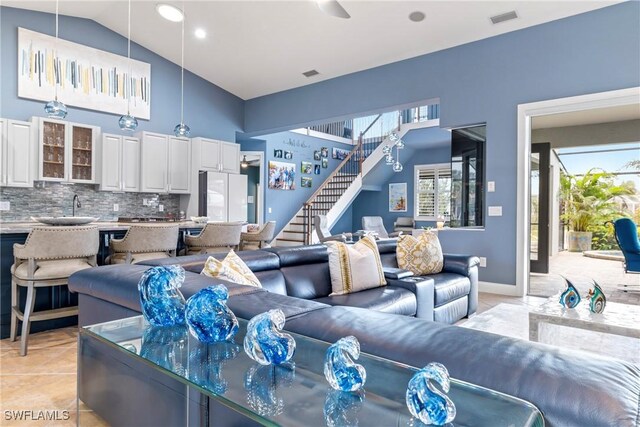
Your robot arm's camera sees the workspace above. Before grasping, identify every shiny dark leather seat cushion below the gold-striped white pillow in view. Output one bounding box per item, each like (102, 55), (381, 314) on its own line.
(314, 286), (417, 316)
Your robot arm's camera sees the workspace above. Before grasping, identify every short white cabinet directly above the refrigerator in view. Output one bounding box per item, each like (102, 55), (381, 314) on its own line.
(193, 138), (240, 176)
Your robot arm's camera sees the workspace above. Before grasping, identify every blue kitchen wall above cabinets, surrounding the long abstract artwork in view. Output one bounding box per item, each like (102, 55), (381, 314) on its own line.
(0, 7), (244, 141)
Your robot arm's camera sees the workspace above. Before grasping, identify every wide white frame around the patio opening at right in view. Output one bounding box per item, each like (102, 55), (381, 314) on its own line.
(516, 87), (640, 296)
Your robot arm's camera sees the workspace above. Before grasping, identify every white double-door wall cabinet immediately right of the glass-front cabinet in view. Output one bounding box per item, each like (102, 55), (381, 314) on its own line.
(100, 133), (140, 192)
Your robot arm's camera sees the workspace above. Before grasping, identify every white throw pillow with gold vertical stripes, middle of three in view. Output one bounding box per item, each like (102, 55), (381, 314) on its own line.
(326, 236), (387, 295)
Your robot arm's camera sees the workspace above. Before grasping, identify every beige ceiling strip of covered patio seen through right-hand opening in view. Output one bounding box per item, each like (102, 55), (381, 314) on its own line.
(531, 104), (640, 129)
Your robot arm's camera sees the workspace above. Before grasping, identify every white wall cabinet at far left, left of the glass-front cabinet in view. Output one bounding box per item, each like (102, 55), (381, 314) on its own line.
(0, 119), (35, 187)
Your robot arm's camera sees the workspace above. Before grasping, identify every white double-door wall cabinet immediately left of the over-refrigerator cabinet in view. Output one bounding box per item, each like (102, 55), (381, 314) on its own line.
(140, 132), (191, 194)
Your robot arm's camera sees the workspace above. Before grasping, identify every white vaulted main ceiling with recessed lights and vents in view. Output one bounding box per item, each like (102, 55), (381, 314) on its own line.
(2, 0), (620, 99)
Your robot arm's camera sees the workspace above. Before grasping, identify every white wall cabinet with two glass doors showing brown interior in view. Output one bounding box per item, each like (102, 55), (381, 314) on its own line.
(37, 118), (99, 183)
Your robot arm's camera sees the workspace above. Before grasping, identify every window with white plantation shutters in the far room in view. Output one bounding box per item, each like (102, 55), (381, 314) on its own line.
(414, 163), (451, 221)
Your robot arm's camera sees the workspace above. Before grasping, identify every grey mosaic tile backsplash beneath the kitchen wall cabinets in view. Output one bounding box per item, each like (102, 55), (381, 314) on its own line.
(0, 181), (180, 221)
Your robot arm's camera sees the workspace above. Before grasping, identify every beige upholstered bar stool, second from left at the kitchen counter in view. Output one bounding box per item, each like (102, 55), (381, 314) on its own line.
(106, 224), (179, 264)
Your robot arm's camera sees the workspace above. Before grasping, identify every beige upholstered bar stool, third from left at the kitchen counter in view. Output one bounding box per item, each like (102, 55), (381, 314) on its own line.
(184, 222), (242, 255)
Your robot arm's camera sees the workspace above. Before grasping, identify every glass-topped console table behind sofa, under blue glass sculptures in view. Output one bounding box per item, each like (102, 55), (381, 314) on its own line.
(78, 316), (544, 427)
